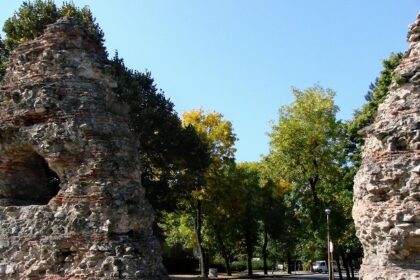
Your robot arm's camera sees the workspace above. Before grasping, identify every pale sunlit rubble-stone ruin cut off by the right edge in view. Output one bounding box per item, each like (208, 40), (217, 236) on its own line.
(353, 15), (420, 280)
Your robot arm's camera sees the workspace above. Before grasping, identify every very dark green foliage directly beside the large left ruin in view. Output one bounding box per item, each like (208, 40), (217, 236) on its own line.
(110, 53), (210, 213)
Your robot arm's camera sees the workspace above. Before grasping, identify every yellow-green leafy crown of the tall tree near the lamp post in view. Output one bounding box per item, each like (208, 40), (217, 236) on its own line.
(270, 87), (338, 184)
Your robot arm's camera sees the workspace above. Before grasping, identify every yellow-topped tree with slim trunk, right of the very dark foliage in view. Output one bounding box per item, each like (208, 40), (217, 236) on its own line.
(158, 110), (236, 275)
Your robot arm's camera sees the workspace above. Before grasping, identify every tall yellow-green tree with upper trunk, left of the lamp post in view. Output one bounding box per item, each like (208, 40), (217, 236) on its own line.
(268, 87), (342, 228)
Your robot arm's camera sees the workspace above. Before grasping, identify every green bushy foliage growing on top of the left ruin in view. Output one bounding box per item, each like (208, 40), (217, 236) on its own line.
(3, 0), (104, 51)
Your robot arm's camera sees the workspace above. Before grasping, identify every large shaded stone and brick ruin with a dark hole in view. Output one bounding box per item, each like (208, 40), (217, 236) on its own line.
(0, 18), (168, 279)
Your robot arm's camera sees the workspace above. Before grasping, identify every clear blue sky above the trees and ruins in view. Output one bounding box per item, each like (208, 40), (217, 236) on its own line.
(0, 0), (420, 161)
